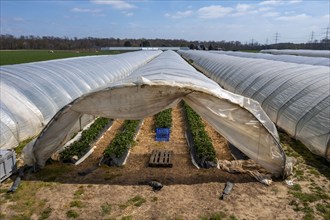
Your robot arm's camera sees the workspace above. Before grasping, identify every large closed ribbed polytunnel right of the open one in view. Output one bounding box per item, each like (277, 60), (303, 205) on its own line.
(179, 51), (330, 160)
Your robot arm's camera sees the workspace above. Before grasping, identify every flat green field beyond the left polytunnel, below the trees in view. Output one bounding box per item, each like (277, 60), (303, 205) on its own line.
(0, 50), (126, 66)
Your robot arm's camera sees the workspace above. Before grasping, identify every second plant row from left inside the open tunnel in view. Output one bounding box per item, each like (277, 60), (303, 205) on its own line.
(103, 120), (140, 158)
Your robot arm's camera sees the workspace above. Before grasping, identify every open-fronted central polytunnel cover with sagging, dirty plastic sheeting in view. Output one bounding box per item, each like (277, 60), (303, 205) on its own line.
(24, 51), (287, 176)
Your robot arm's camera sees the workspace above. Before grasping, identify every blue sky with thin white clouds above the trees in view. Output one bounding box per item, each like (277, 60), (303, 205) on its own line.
(0, 0), (330, 44)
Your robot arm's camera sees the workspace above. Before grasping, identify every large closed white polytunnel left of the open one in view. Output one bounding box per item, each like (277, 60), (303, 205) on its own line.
(0, 51), (161, 149)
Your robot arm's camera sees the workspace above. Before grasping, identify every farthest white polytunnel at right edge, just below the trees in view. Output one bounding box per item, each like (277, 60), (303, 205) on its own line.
(260, 49), (330, 58)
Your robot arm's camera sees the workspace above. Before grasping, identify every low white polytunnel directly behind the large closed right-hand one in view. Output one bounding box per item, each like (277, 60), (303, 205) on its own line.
(210, 51), (330, 67)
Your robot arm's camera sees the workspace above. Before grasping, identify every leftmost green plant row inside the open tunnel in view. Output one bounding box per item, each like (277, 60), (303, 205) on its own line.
(60, 118), (110, 161)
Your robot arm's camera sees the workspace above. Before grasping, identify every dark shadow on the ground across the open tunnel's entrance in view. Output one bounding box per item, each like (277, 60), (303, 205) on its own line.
(24, 155), (257, 185)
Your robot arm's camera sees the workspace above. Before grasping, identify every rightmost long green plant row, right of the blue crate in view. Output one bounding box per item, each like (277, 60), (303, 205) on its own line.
(183, 103), (217, 167)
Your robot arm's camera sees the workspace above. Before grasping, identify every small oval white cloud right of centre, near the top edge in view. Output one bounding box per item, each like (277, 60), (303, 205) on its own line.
(197, 5), (234, 19)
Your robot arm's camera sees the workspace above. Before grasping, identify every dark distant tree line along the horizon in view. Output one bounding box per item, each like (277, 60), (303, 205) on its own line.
(0, 34), (330, 50)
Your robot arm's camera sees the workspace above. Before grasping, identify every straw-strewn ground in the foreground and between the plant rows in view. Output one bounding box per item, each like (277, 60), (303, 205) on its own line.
(0, 105), (330, 220)
